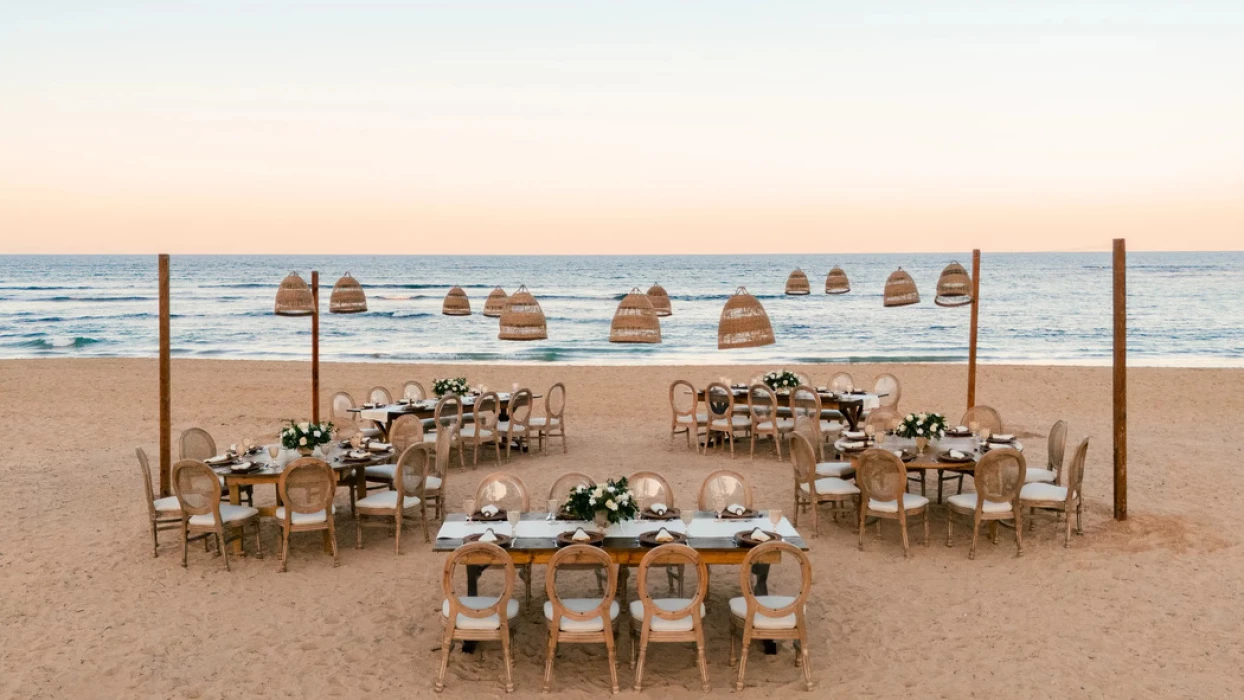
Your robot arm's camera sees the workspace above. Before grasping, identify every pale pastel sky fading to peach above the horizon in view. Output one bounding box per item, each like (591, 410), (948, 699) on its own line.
(0, 0), (1244, 254)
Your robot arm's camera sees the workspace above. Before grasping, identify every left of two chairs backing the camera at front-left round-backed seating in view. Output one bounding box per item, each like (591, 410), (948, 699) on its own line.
(173, 459), (264, 571)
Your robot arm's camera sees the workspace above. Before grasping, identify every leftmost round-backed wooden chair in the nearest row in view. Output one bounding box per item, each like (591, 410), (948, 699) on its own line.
(435, 542), (519, 693)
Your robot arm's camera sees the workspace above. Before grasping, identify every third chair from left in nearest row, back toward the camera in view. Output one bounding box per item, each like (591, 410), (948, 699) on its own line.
(628, 545), (710, 693)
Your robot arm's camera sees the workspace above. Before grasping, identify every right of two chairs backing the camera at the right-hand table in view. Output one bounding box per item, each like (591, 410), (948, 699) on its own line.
(945, 448), (1025, 560)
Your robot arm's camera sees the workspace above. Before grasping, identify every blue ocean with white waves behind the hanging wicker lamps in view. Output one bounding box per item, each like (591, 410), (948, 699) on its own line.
(0, 252), (1244, 367)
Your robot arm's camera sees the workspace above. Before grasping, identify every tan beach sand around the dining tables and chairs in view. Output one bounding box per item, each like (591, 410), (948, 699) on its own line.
(0, 359), (1244, 698)
